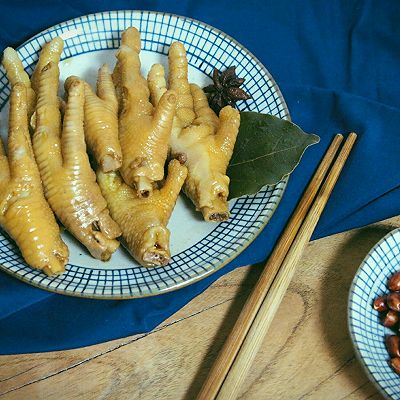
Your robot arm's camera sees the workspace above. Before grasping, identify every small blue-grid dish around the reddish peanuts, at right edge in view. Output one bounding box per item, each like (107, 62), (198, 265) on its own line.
(348, 229), (400, 400)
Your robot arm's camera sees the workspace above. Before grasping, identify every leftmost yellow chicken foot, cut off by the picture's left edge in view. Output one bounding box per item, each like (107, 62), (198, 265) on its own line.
(0, 83), (68, 275)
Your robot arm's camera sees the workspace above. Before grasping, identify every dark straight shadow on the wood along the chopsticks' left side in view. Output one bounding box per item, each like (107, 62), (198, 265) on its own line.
(184, 263), (264, 400)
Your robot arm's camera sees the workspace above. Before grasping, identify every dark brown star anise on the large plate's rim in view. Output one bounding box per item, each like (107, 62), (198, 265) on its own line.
(203, 66), (251, 115)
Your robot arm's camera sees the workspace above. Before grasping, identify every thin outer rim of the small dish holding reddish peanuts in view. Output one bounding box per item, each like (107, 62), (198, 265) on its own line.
(347, 228), (400, 400)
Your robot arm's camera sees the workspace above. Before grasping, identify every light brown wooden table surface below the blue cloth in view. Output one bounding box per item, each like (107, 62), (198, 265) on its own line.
(0, 217), (400, 400)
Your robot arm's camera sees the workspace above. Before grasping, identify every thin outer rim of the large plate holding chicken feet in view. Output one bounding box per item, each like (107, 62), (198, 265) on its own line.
(0, 9), (291, 300)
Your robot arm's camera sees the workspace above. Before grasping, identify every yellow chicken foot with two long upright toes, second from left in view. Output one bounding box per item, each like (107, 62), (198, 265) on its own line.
(33, 61), (121, 261)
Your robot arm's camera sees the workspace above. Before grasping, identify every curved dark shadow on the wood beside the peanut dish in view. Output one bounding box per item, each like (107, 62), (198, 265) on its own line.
(320, 224), (394, 398)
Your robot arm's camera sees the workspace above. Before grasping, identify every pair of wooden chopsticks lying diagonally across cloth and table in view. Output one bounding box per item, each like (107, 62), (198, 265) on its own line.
(197, 133), (357, 400)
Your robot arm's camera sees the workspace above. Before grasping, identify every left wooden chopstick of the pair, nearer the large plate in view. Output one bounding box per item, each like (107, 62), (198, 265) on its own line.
(197, 135), (353, 400)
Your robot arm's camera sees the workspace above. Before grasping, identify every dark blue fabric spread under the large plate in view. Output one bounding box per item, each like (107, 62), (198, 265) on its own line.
(0, 0), (400, 354)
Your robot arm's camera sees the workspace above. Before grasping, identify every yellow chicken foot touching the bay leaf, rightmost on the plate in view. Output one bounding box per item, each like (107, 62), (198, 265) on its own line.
(148, 42), (240, 222)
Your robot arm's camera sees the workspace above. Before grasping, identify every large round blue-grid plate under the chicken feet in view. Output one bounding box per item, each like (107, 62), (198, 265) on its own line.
(0, 11), (289, 299)
